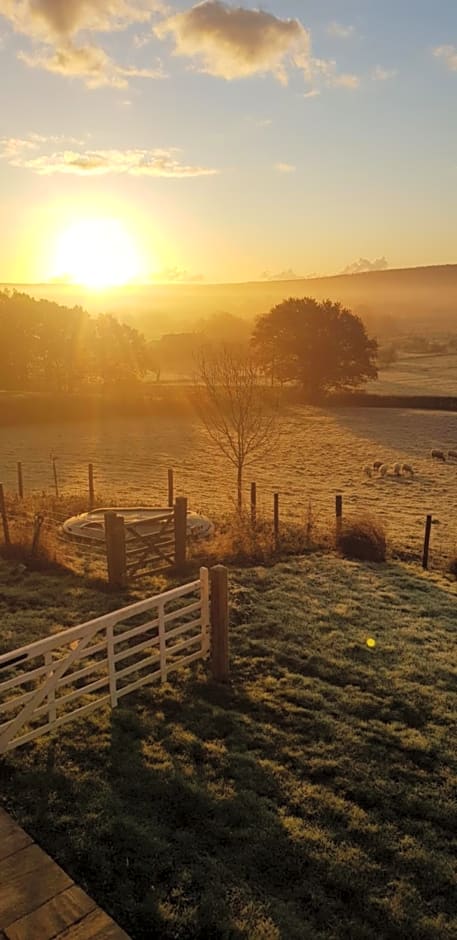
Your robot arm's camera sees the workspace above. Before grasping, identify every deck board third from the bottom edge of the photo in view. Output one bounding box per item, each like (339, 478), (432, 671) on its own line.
(0, 859), (73, 930)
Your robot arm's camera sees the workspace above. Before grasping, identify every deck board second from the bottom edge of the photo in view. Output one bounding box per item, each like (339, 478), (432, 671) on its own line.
(6, 885), (96, 940)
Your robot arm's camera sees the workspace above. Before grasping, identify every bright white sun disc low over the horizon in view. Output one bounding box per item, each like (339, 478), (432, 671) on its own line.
(53, 219), (141, 290)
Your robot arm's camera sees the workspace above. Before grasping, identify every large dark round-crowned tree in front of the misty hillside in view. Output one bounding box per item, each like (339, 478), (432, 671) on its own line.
(252, 297), (378, 401)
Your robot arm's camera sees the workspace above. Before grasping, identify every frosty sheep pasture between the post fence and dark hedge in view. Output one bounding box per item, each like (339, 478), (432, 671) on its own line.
(0, 408), (457, 555)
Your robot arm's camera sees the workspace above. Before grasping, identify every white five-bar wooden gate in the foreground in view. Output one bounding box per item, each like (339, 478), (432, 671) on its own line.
(0, 568), (209, 754)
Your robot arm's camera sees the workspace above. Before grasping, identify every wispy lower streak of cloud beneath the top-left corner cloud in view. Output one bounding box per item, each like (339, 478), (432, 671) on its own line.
(18, 44), (164, 88)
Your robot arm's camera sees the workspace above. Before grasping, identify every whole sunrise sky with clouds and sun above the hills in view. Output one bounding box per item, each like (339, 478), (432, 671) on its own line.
(0, 0), (457, 286)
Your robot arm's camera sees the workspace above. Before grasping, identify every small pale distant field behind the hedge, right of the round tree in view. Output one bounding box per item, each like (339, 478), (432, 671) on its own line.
(367, 353), (457, 395)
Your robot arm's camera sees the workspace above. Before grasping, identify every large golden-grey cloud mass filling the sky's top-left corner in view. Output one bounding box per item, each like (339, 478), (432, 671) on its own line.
(0, 0), (165, 88)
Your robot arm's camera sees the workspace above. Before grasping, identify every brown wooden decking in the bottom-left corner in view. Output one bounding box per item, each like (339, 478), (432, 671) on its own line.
(0, 809), (129, 940)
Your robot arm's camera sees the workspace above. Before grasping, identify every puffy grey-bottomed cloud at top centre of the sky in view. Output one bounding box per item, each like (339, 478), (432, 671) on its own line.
(155, 0), (310, 84)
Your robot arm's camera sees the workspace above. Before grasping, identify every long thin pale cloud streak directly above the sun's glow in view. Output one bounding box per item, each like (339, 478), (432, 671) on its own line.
(0, 138), (218, 179)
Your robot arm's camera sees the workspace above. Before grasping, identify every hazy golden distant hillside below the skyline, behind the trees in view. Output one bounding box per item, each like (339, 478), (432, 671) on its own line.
(5, 265), (457, 335)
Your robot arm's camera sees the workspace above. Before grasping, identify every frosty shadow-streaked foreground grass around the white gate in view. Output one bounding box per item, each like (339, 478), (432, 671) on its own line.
(0, 555), (457, 940)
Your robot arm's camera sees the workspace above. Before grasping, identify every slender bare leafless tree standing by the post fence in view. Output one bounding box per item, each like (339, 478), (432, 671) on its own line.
(195, 349), (276, 510)
